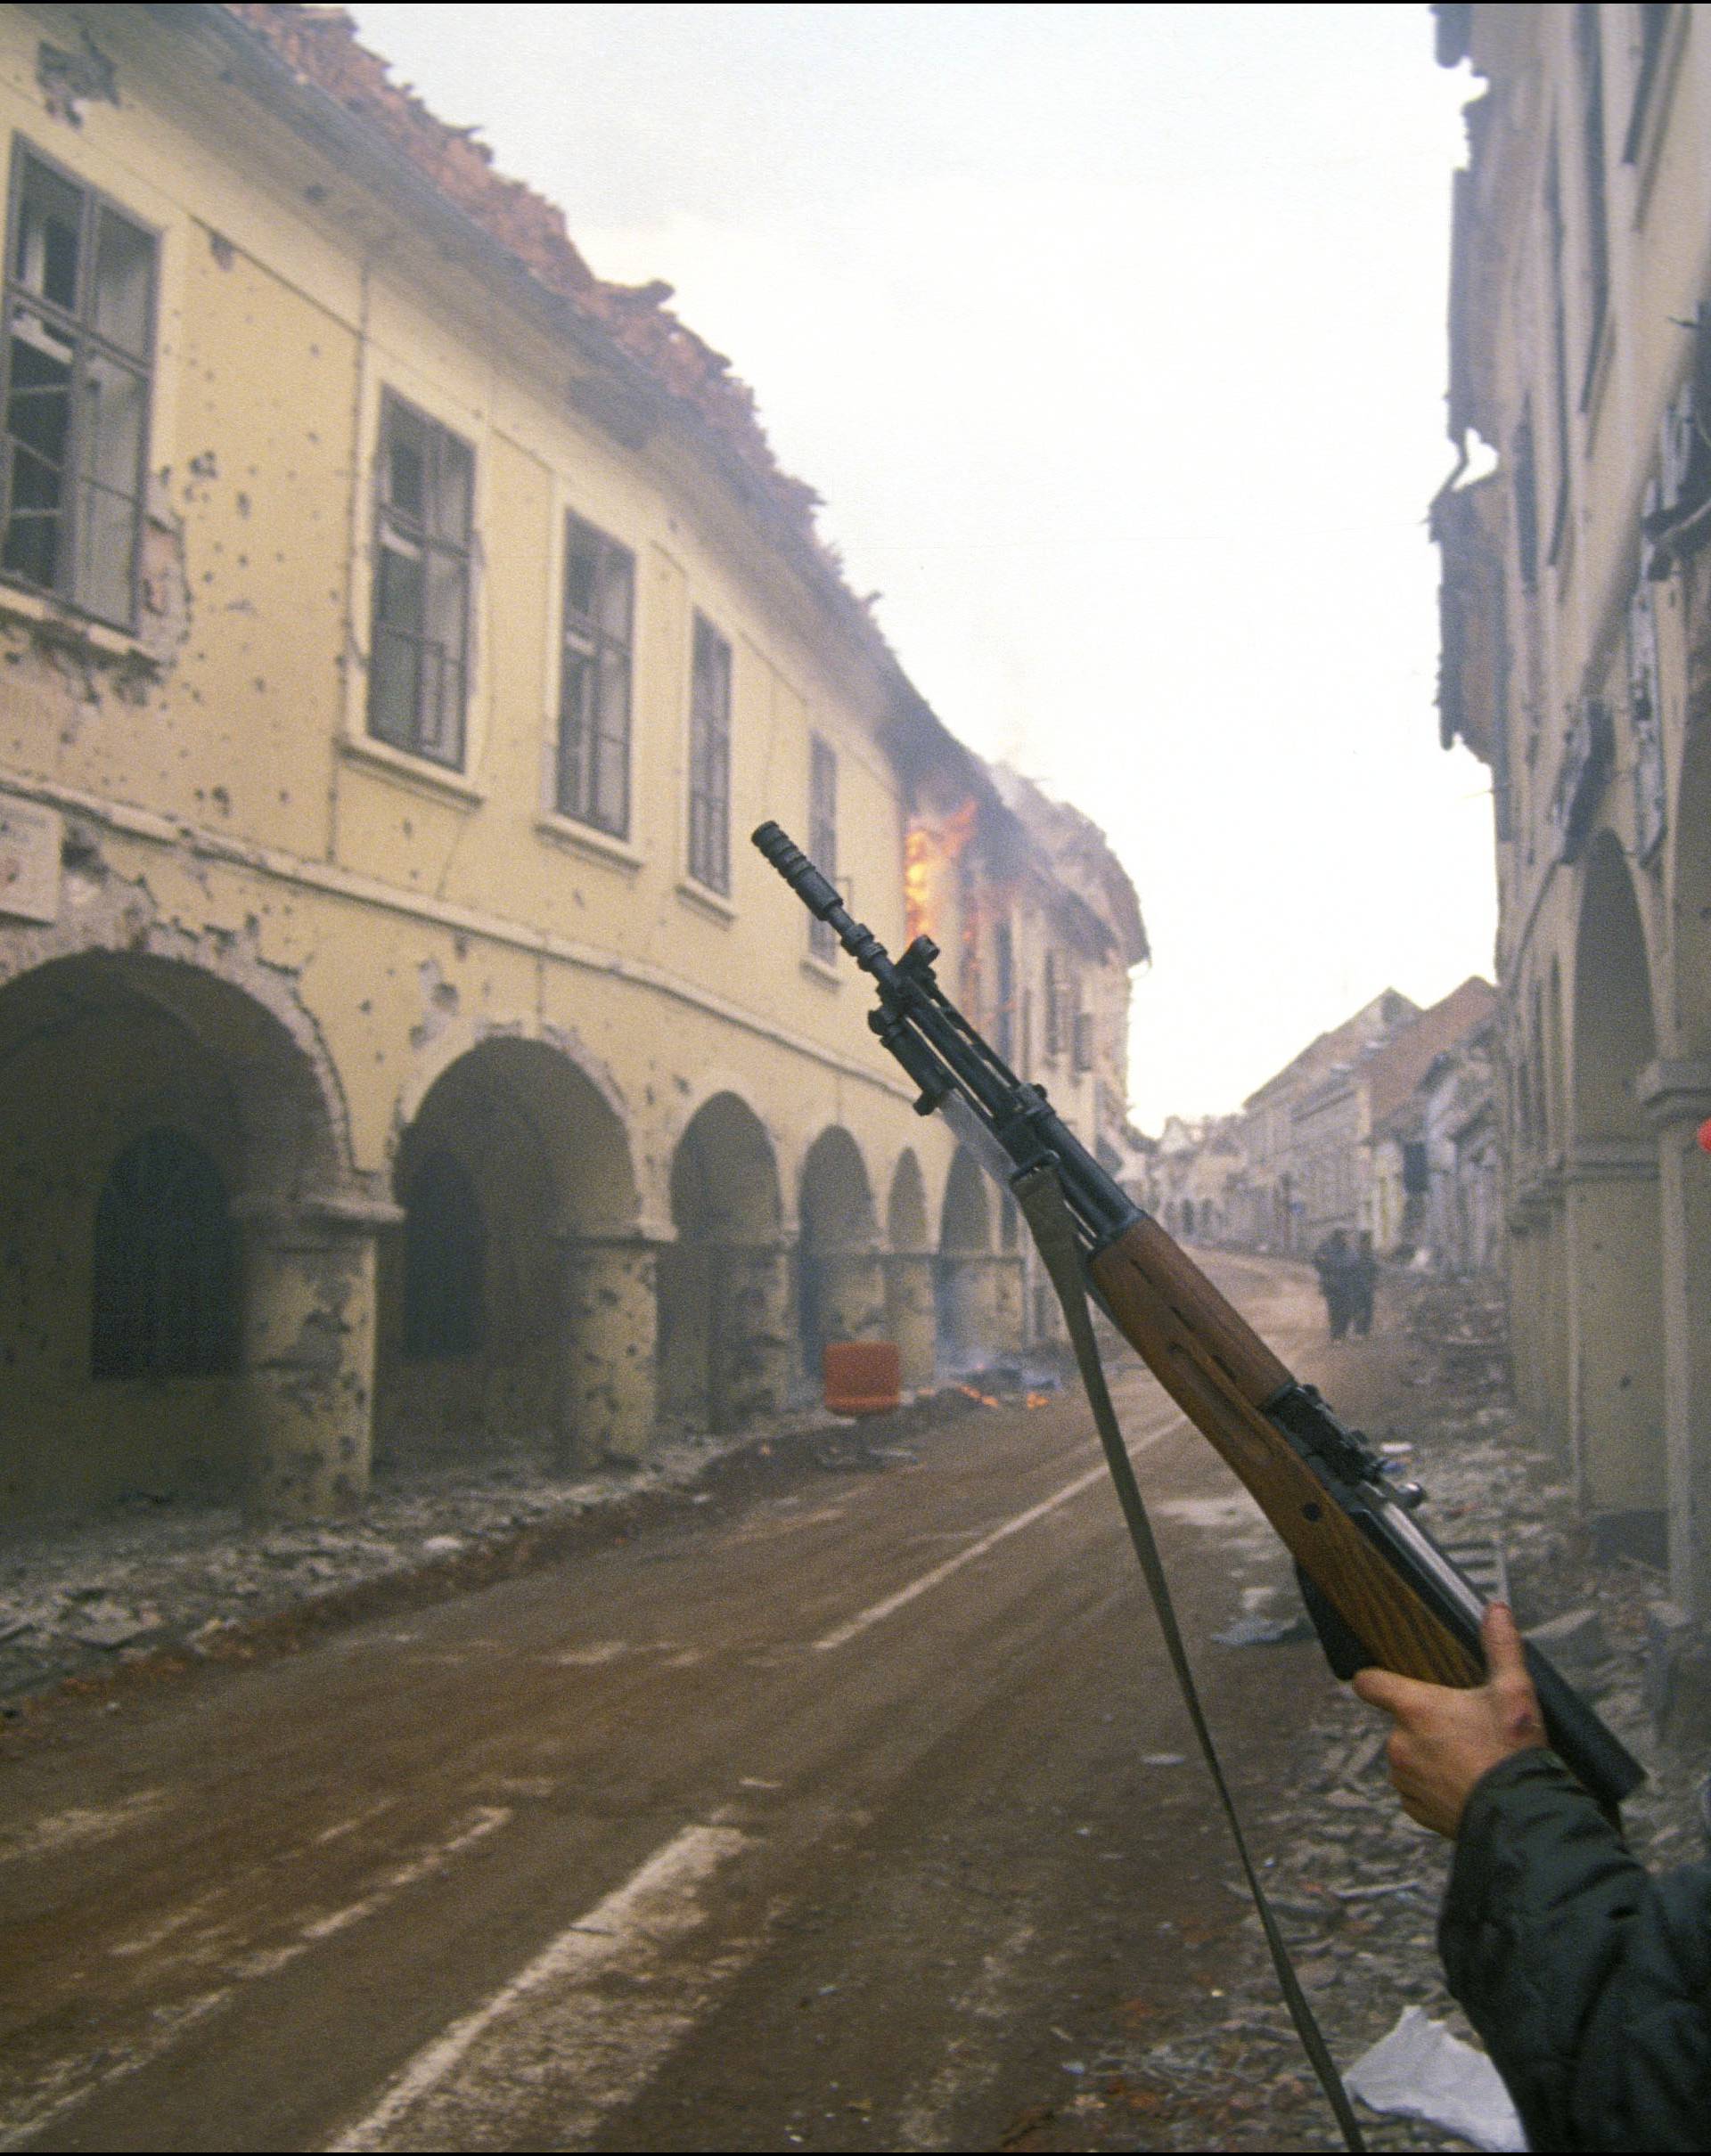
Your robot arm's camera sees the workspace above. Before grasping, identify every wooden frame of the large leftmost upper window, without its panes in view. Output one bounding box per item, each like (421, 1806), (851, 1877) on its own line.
(0, 134), (166, 633)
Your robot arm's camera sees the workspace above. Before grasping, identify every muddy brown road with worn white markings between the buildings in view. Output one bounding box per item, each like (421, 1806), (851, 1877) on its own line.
(0, 1259), (1329, 2150)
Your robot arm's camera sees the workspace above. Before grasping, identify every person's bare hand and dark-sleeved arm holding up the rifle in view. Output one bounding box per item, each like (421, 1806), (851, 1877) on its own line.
(1355, 1604), (1711, 2150)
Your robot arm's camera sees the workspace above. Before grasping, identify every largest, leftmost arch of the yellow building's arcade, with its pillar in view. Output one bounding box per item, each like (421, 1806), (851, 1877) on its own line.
(0, 951), (356, 1509)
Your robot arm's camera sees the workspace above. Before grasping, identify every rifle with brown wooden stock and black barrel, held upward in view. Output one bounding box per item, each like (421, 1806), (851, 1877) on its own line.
(753, 823), (1644, 1816)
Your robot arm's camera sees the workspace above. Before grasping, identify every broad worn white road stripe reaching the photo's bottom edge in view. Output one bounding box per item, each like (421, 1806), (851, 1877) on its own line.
(328, 1824), (757, 2150)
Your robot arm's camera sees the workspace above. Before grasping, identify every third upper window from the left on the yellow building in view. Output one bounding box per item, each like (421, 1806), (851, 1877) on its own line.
(557, 518), (636, 838)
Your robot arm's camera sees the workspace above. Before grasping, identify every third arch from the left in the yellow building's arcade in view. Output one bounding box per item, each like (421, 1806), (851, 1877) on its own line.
(658, 1091), (794, 1432)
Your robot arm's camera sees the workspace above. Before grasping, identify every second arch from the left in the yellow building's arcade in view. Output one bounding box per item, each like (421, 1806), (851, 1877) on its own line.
(380, 1033), (651, 1464)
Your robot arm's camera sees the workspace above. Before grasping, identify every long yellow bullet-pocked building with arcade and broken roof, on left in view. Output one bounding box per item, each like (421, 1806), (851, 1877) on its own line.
(0, 4), (1142, 1515)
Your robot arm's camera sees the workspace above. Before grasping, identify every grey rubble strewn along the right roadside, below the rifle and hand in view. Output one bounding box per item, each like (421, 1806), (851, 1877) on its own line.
(1012, 1277), (1711, 2150)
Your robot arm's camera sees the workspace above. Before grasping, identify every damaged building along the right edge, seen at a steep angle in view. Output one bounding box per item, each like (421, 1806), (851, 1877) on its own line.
(1433, 6), (1711, 1623)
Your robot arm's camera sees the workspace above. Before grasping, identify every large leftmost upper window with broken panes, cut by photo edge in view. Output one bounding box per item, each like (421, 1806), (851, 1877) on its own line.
(0, 143), (158, 630)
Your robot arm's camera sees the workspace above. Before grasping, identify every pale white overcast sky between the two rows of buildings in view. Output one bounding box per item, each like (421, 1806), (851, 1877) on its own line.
(352, 4), (1495, 1130)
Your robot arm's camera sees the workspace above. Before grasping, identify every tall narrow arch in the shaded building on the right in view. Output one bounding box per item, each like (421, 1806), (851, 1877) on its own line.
(1567, 832), (1666, 1556)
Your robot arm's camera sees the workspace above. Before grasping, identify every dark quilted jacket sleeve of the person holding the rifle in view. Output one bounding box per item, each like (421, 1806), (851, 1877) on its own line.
(1439, 1751), (1711, 2150)
